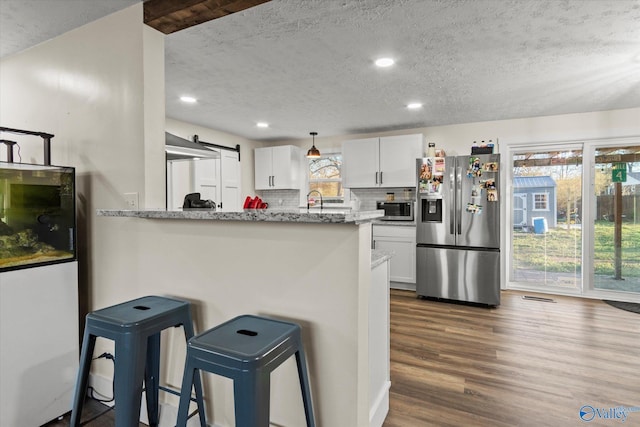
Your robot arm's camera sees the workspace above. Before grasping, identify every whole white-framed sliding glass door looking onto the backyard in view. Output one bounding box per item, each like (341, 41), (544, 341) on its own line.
(506, 139), (640, 299)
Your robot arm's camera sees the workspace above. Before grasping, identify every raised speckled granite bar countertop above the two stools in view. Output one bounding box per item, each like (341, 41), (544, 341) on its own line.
(97, 209), (384, 224)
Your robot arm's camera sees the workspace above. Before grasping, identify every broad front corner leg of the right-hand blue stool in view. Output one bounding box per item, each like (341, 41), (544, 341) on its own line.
(233, 371), (271, 427)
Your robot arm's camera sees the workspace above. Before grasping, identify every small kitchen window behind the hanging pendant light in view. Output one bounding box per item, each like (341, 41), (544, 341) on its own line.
(309, 153), (344, 203)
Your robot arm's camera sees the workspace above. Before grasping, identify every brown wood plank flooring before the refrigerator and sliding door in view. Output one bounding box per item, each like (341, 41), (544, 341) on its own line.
(384, 290), (640, 427)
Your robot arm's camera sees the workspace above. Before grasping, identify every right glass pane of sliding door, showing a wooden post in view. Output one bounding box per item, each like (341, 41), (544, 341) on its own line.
(593, 146), (640, 292)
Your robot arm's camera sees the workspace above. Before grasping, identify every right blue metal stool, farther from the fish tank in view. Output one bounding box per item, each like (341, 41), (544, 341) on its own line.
(177, 315), (315, 427)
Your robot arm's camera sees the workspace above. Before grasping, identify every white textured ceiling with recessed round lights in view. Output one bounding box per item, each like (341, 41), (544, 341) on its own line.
(0, 0), (640, 141)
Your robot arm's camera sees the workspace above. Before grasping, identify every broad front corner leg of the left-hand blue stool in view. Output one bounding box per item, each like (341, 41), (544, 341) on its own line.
(114, 334), (147, 427)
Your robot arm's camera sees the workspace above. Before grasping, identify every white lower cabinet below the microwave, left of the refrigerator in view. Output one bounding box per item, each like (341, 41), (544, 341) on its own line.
(372, 224), (416, 289)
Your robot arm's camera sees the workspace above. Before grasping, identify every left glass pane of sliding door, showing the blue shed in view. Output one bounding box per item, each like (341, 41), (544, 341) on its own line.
(510, 150), (582, 288)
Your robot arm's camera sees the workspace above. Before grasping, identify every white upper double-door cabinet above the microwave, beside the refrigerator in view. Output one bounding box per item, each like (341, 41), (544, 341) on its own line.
(342, 134), (423, 188)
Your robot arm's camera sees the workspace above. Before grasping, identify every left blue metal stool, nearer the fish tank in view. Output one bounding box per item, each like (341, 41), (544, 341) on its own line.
(70, 296), (206, 427)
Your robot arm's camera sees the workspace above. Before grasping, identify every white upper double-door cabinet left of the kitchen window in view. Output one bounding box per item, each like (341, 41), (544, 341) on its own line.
(254, 145), (300, 190)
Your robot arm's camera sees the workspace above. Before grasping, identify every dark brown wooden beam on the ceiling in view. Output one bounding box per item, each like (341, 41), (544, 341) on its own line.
(144, 0), (270, 34)
